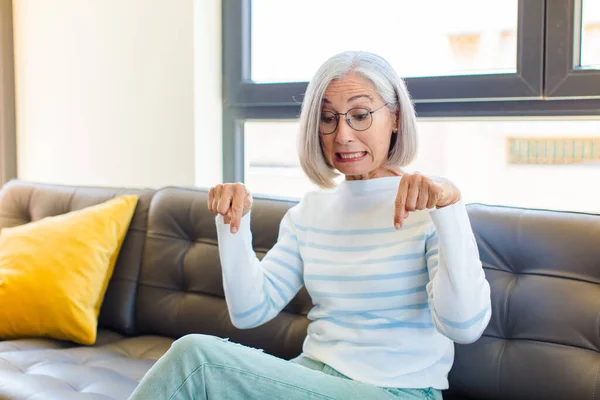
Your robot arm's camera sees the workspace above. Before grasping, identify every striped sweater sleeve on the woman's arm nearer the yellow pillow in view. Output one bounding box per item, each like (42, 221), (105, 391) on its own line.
(216, 211), (304, 329)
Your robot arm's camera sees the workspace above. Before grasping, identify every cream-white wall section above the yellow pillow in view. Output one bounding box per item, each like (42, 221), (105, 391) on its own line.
(14, 0), (197, 187)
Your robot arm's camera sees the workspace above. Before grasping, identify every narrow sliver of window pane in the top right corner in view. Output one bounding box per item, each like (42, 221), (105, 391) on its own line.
(581, 0), (600, 68)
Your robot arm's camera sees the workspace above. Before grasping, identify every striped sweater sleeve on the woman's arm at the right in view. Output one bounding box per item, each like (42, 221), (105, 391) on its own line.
(425, 200), (491, 343)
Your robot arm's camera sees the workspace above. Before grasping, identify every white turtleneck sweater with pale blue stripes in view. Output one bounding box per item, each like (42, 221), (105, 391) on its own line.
(217, 177), (491, 389)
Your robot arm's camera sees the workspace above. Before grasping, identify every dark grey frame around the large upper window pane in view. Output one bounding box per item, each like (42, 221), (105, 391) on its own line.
(223, 0), (545, 107)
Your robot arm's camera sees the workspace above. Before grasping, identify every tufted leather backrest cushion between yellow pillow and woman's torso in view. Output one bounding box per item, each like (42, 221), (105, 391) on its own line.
(136, 188), (311, 359)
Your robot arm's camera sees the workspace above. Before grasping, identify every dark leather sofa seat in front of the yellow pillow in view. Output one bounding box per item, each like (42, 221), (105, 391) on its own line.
(0, 332), (173, 400)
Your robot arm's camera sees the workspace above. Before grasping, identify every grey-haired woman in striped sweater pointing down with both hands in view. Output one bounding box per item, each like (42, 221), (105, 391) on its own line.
(133, 52), (491, 399)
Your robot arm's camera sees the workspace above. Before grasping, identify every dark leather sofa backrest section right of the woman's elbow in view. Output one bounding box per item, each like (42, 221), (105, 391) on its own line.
(445, 204), (600, 400)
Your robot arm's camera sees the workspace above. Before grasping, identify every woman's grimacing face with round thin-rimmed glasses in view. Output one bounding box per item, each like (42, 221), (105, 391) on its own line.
(319, 73), (398, 179)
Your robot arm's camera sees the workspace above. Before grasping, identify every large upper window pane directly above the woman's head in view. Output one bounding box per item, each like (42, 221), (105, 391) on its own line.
(251, 0), (518, 82)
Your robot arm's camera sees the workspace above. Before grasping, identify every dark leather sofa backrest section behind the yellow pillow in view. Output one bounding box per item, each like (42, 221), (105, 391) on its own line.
(0, 180), (154, 334)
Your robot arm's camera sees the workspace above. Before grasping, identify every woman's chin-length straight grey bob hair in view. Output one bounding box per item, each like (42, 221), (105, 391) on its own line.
(298, 51), (417, 188)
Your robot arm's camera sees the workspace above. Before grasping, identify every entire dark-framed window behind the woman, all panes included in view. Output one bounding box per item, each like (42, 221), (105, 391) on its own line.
(223, 0), (600, 212)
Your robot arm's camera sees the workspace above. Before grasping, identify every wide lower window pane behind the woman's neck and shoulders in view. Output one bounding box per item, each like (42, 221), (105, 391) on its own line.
(245, 119), (600, 212)
